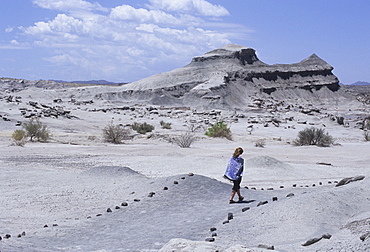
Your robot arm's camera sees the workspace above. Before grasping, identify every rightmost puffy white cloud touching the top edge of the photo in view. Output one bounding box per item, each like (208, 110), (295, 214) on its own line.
(149, 0), (229, 17)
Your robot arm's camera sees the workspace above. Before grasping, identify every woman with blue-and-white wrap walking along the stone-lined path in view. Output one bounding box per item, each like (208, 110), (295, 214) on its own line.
(224, 147), (244, 204)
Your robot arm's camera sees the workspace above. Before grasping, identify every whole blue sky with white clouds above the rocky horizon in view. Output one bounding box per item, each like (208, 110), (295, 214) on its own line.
(0, 0), (370, 84)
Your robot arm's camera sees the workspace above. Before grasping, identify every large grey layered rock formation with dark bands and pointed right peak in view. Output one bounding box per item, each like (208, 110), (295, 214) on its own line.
(97, 45), (344, 109)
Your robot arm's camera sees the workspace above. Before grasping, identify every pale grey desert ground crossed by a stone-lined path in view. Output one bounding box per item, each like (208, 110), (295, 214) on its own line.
(0, 85), (370, 252)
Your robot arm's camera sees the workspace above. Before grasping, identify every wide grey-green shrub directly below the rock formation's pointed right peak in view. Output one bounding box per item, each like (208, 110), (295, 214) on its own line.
(293, 127), (334, 147)
